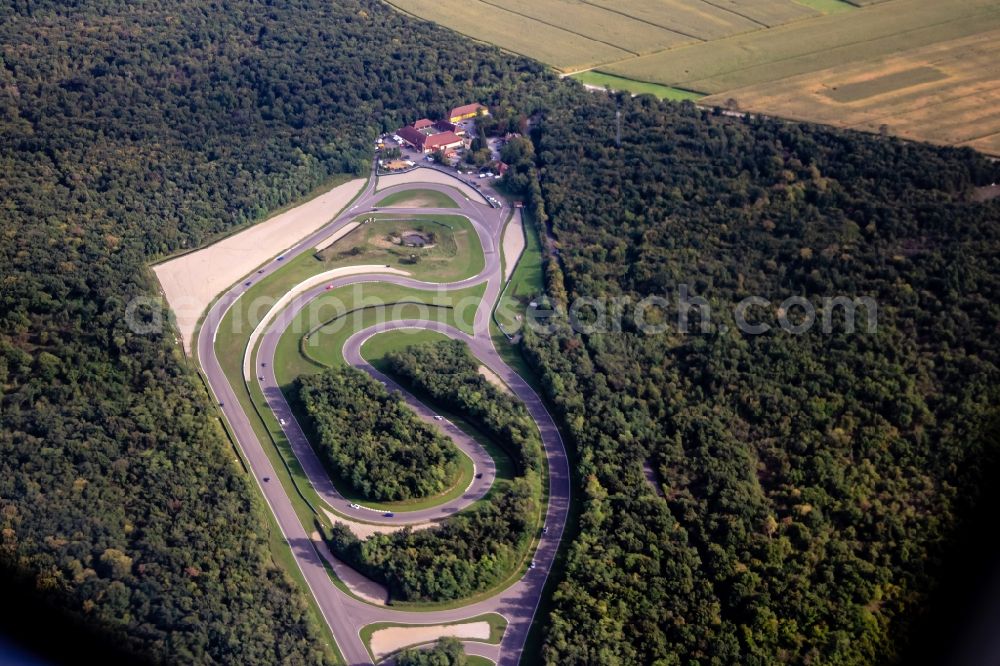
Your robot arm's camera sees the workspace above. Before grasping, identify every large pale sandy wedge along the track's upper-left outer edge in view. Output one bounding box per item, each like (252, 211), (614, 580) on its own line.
(153, 178), (365, 353)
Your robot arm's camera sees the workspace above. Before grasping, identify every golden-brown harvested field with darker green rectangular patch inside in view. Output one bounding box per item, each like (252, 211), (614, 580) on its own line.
(704, 28), (1000, 154)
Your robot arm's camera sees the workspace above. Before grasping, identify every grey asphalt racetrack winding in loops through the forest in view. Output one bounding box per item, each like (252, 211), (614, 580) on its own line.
(197, 163), (570, 666)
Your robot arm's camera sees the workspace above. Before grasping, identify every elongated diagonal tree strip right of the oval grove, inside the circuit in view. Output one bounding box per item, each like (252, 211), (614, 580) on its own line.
(386, 340), (542, 473)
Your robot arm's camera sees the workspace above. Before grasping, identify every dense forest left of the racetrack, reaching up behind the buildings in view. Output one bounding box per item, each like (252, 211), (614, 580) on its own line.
(0, 0), (549, 664)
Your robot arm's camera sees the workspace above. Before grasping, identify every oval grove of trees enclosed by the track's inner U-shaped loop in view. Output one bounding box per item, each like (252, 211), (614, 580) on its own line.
(293, 367), (460, 501)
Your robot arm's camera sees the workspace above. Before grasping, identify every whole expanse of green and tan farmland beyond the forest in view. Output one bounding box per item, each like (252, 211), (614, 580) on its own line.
(391, 0), (1000, 154)
